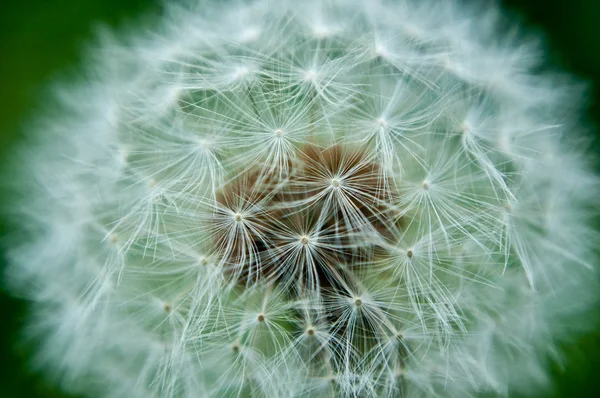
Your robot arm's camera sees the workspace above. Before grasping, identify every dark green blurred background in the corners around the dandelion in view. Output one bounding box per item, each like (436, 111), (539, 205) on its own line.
(0, 0), (600, 398)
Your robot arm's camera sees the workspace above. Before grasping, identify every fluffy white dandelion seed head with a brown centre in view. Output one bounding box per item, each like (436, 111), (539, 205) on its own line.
(2, 0), (598, 398)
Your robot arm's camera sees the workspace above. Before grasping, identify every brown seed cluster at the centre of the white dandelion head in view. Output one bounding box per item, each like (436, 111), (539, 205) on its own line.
(212, 144), (401, 296)
